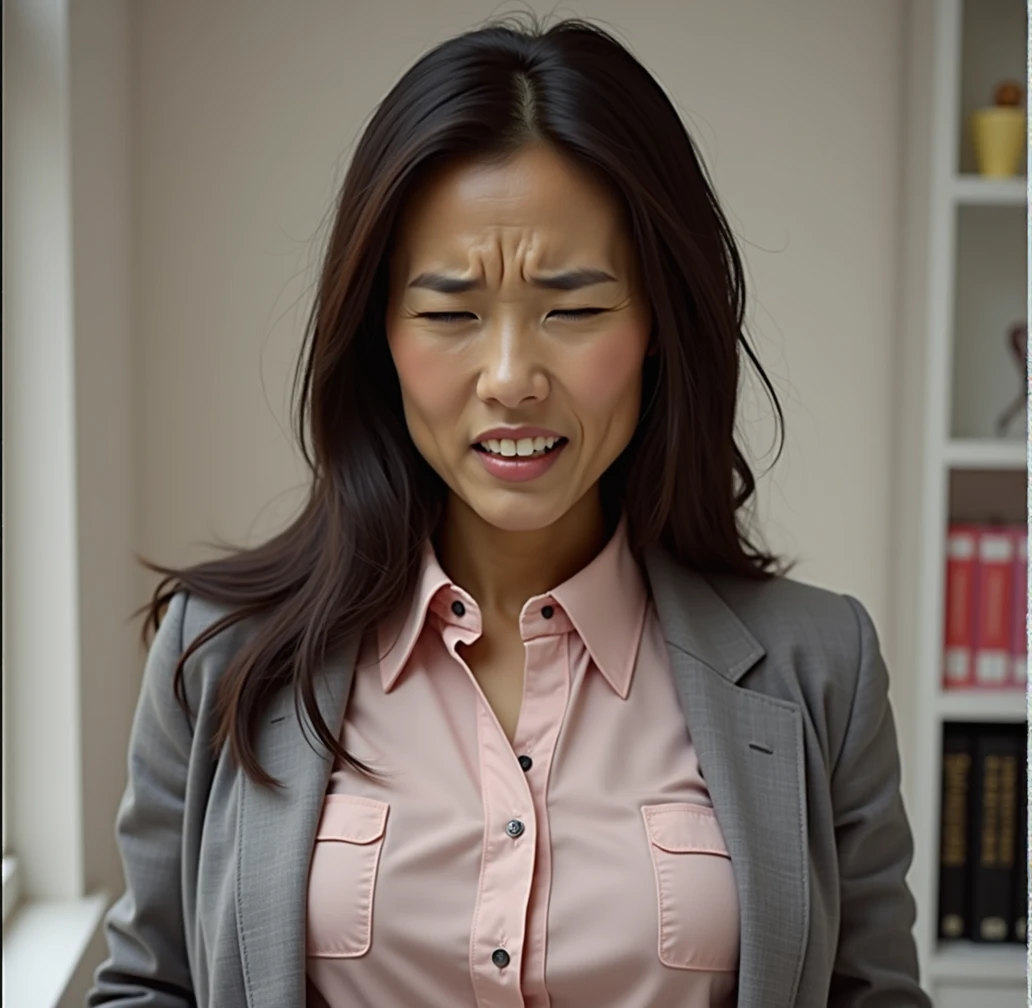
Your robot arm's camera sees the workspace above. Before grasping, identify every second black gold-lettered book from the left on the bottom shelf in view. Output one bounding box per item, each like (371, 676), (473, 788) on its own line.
(968, 724), (1022, 943)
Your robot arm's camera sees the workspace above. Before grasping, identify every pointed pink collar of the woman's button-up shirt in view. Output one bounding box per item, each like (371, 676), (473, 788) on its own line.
(378, 518), (648, 700)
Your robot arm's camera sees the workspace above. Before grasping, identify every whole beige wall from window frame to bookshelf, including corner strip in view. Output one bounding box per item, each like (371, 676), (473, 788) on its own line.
(12, 0), (910, 887)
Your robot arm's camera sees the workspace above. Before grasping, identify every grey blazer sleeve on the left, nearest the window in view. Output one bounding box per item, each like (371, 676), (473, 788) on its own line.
(86, 591), (196, 1008)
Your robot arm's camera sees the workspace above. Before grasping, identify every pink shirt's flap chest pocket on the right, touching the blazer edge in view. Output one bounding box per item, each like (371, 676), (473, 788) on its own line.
(642, 802), (740, 972)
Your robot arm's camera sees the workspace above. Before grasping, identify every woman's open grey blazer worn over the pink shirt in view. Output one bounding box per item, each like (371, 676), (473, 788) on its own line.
(87, 551), (931, 1008)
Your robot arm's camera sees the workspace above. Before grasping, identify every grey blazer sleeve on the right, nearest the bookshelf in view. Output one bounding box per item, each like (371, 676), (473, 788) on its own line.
(828, 595), (932, 1008)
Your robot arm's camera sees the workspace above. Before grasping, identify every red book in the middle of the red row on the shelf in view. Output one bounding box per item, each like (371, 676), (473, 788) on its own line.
(974, 525), (1014, 689)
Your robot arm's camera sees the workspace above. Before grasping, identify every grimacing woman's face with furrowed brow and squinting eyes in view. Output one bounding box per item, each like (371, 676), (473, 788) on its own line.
(386, 147), (650, 531)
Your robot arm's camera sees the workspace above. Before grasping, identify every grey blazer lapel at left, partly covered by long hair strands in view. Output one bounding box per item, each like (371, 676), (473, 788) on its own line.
(236, 631), (357, 1008)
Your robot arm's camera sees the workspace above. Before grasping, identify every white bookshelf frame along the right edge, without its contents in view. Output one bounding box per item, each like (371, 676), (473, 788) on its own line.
(893, 0), (1032, 1008)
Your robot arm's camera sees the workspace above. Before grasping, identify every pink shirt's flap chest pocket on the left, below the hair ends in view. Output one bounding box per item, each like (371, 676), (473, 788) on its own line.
(308, 794), (390, 958)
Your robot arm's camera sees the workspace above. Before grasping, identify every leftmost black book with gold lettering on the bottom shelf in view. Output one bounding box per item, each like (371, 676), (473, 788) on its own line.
(939, 724), (974, 939)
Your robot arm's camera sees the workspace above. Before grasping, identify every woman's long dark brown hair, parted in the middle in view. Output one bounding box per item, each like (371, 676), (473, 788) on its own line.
(137, 15), (787, 786)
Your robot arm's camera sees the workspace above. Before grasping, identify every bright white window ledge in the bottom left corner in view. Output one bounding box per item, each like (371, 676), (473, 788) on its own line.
(3, 892), (107, 1008)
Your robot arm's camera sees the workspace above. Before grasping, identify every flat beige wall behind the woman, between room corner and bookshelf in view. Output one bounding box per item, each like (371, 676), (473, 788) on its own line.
(133, 0), (908, 759)
